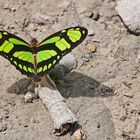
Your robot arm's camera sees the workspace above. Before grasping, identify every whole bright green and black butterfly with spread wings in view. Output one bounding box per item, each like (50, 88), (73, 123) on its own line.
(0, 27), (88, 76)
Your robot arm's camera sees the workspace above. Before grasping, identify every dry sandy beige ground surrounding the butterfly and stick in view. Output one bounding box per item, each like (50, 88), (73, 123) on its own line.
(0, 0), (140, 140)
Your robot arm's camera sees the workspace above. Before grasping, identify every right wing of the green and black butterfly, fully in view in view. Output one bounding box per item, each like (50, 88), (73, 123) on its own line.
(37, 27), (88, 74)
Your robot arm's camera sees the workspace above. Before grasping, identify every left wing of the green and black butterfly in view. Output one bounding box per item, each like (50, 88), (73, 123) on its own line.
(0, 31), (34, 76)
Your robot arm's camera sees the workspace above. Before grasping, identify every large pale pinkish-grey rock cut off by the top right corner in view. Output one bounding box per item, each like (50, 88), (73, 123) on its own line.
(116, 0), (140, 34)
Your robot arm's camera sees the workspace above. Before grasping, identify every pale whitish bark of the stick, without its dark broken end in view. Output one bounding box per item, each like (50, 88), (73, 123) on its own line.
(37, 87), (77, 129)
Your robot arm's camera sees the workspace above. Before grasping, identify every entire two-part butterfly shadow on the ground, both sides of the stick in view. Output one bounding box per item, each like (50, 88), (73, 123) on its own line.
(7, 72), (115, 98)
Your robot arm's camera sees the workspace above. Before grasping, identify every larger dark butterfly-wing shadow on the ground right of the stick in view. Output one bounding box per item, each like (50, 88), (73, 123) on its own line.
(52, 72), (115, 98)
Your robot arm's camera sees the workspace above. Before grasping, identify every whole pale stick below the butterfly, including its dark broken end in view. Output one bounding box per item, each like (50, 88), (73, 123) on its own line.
(25, 75), (86, 140)
